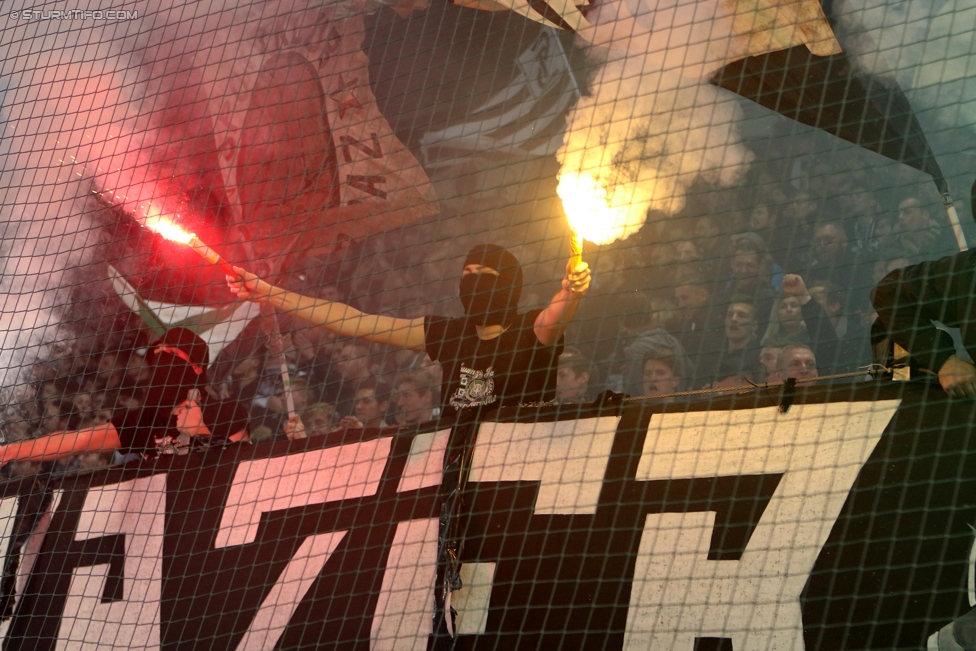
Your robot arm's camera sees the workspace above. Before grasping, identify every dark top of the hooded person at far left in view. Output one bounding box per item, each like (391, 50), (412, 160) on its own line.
(112, 392), (247, 457)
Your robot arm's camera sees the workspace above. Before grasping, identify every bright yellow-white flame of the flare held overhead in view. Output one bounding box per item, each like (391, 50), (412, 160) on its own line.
(556, 172), (629, 244)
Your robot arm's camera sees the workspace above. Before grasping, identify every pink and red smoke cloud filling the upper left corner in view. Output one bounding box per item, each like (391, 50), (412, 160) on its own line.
(0, 0), (278, 387)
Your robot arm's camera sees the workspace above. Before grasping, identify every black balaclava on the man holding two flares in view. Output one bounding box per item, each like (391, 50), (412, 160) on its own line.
(460, 244), (522, 326)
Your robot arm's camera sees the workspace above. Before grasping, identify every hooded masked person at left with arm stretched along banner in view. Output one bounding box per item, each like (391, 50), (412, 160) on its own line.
(0, 328), (247, 465)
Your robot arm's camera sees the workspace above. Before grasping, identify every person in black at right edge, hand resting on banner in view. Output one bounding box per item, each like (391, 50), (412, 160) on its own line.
(873, 249), (976, 398)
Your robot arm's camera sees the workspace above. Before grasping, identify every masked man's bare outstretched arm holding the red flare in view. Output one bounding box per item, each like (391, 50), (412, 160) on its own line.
(227, 267), (424, 350)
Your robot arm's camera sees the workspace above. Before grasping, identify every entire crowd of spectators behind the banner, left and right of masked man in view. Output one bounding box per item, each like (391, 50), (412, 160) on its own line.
(3, 186), (951, 469)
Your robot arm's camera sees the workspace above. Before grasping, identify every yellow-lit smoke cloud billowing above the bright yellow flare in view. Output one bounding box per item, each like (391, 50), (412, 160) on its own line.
(557, 50), (752, 241)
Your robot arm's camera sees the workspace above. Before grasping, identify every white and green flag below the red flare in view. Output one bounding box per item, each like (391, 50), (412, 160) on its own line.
(108, 265), (261, 362)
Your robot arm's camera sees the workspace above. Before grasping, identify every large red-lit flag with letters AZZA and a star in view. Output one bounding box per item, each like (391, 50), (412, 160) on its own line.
(204, 2), (438, 257)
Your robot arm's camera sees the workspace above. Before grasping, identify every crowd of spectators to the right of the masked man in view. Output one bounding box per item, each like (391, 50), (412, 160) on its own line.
(560, 197), (952, 401)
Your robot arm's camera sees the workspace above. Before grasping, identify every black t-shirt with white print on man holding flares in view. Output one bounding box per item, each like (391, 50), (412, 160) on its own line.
(424, 310), (563, 411)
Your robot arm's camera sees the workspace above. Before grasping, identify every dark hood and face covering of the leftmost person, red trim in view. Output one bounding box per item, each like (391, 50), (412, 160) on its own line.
(143, 328), (210, 438)
